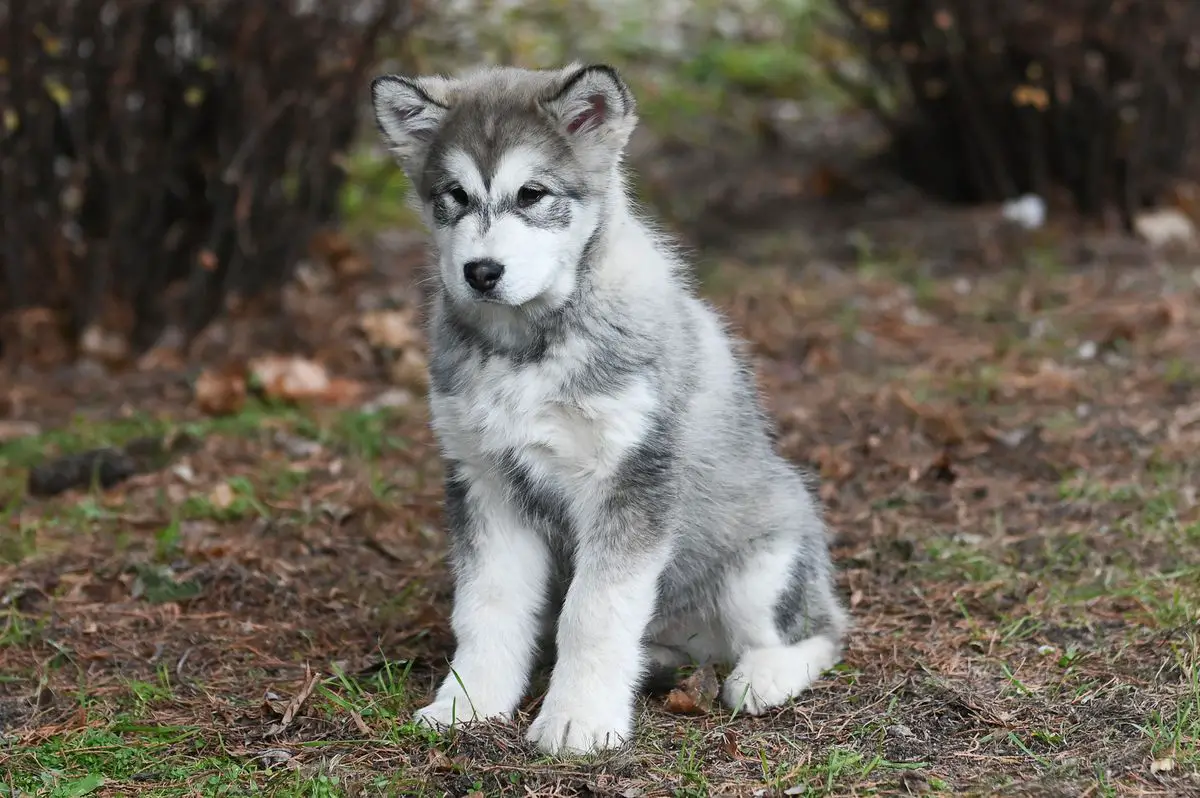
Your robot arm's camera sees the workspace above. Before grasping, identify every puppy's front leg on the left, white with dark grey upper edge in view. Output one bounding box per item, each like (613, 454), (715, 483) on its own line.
(416, 467), (551, 726)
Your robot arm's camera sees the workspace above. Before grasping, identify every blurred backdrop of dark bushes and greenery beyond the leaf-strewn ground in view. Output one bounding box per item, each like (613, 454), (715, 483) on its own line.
(0, 0), (1200, 374)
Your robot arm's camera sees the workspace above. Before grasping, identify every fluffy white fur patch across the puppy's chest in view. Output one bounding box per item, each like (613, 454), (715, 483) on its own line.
(433, 364), (655, 478)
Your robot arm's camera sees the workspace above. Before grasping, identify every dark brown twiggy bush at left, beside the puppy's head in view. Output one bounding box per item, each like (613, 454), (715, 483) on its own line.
(0, 0), (416, 364)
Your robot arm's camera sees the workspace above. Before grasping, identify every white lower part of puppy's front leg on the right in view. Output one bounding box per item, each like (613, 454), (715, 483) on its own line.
(528, 544), (666, 754)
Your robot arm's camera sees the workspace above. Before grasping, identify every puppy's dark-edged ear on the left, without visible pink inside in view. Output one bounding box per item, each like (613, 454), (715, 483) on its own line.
(371, 74), (449, 173)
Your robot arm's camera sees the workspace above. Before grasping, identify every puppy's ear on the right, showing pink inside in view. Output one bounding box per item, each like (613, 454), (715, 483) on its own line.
(544, 64), (637, 165)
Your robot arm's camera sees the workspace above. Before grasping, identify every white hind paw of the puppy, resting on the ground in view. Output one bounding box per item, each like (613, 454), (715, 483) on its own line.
(721, 637), (836, 715)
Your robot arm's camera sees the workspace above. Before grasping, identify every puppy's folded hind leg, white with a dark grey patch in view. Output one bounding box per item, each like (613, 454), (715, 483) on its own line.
(721, 521), (847, 715)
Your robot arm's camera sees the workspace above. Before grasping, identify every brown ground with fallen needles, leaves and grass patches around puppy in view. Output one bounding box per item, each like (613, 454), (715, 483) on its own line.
(0, 164), (1200, 798)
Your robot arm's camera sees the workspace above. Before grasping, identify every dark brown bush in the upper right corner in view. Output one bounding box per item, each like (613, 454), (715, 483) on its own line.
(836, 0), (1200, 227)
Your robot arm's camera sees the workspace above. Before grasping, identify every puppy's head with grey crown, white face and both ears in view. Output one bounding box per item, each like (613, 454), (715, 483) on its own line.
(371, 65), (637, 307)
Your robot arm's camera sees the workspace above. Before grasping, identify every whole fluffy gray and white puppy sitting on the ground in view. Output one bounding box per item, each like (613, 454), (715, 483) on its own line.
(371, 65), (848, 754)
